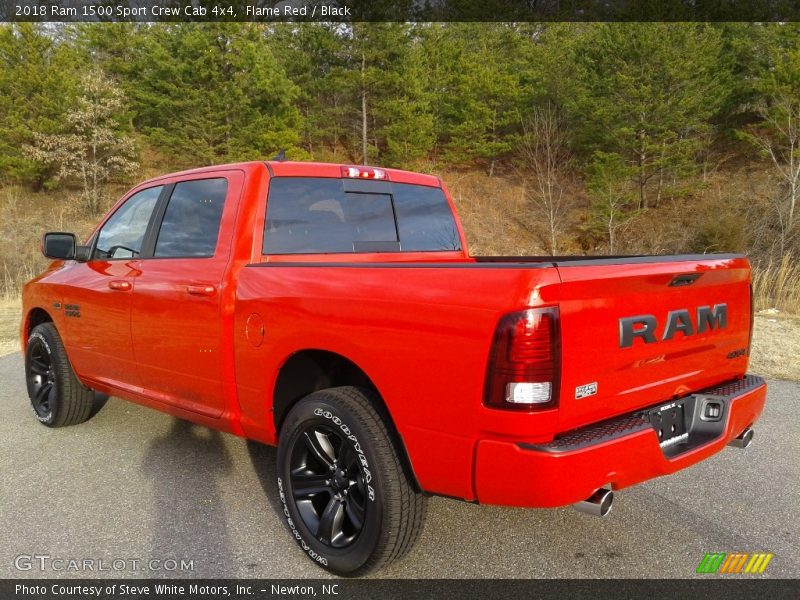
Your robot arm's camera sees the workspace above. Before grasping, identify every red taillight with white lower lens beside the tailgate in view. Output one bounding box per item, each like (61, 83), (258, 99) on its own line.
(484, 307), (561, 411)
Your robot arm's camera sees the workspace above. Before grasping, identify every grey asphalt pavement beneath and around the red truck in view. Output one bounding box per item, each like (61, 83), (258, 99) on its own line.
(0, 354), (800, 578)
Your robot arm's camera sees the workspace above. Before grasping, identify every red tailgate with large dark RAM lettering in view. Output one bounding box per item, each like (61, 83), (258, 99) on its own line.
(556, 255), (751, 431)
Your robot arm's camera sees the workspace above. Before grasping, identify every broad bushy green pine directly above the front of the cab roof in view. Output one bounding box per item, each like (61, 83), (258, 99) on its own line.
(130, 23), (302, 164)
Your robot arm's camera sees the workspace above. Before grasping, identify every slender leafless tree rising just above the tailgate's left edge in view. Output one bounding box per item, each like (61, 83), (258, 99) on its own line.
(520, 103), (572, 256)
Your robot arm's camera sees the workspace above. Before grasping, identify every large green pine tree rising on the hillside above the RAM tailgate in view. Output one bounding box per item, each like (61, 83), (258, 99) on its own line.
(562, 23), (730, 208)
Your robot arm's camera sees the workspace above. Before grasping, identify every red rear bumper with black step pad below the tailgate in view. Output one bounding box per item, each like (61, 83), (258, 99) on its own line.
(475, 375), (767, 507)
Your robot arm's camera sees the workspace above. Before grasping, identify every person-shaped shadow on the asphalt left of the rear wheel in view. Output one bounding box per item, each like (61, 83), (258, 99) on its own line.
(142, 418), (233, 577)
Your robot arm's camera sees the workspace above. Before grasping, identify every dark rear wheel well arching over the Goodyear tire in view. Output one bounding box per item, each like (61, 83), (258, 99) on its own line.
(272, 350), (422, 491)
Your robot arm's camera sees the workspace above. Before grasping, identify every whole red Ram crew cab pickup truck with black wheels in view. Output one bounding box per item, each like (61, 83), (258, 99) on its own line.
(21, 161), (766, 575)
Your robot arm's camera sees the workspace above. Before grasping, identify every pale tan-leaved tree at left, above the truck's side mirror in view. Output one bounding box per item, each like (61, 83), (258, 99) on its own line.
(26, 70), (138, 214)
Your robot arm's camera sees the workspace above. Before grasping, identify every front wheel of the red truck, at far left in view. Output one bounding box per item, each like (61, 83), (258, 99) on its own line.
(25, 323), (96, 427)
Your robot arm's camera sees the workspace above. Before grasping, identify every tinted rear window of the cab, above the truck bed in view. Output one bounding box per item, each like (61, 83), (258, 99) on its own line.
(263, 177), (461, 254)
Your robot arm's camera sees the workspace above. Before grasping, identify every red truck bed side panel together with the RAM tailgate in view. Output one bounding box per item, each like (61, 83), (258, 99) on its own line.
(236, 255), (750, 497)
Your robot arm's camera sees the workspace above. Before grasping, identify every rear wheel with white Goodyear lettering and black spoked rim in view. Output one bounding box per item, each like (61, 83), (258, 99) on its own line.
(277, 387), (427, 576)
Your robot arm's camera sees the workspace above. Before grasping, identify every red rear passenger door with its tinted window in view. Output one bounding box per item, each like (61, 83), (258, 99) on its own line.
(131, 171), (244, 417)
